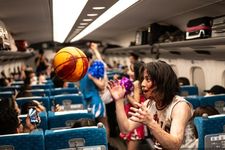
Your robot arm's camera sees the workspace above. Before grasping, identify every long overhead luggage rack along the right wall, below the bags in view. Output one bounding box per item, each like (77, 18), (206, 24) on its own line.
(105, 37), (225, 60)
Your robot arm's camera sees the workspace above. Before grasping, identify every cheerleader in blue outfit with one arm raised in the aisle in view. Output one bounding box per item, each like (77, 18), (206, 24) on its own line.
(79, 43), (115, 150)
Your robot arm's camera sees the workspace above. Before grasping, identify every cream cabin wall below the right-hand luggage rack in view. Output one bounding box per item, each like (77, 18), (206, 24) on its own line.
(107, 56), (225, 95)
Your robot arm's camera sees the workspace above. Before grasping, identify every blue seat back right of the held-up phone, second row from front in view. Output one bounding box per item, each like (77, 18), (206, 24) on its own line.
(48, 110), (94, 129)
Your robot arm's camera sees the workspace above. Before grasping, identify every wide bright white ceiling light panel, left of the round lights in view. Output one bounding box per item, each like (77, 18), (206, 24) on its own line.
(52, 0), (88, 43)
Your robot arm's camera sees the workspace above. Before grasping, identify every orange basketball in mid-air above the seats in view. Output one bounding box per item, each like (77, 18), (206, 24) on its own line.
(53, 47), (88, 82)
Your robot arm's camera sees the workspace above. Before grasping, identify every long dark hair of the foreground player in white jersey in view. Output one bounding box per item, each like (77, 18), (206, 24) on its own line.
(140, 61), (179, 109)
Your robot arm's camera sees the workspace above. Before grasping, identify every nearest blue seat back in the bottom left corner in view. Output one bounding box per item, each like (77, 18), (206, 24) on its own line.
(0, 130), (45, 150)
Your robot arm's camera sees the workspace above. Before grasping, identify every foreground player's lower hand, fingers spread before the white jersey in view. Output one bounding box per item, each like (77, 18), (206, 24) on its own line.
(128, 102), (155, 125)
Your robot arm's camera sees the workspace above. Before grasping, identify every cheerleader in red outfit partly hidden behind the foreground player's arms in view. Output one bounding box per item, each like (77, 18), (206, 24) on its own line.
(120, 61), (145, 150)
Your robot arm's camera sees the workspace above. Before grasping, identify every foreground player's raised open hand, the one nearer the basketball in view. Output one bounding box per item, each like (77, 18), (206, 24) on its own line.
(107, 80), (126, 101)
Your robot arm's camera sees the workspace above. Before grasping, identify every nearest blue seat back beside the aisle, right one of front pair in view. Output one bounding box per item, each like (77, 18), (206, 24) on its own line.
(45, 126), (108, 150)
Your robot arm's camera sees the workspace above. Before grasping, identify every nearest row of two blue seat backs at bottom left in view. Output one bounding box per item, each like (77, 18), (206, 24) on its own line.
(0, 125), (108, 150)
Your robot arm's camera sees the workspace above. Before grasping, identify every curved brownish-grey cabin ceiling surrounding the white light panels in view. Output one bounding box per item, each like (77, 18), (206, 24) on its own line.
(0, 0), (225, 44)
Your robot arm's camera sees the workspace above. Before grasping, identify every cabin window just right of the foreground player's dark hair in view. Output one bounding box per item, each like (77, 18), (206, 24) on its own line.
(191, 67), (205, 95)
